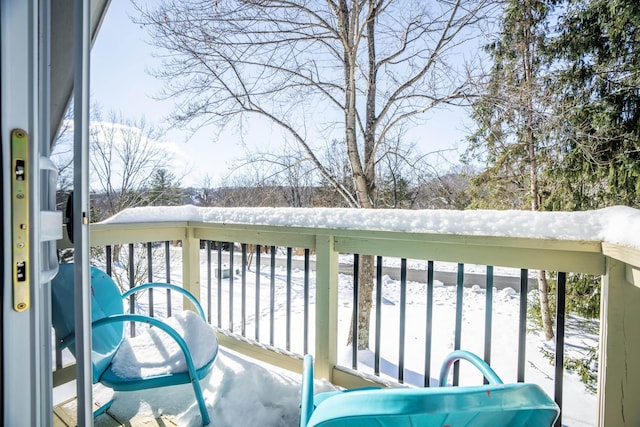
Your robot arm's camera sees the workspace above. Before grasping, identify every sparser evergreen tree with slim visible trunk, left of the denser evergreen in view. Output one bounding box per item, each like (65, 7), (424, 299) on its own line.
(467, 0), (554, 340)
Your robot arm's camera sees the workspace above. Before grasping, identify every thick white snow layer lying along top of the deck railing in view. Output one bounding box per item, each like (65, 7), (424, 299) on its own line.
(103, 205), (640, 249)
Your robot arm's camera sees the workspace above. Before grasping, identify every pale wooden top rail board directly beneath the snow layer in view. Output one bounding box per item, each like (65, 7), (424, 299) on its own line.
(91, 221), (605, 274)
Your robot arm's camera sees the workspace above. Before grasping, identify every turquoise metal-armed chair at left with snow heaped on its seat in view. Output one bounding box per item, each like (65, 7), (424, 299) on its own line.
(51, 264), (218, 425)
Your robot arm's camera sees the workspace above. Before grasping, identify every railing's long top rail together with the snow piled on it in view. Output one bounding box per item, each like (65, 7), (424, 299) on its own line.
(82, 206), (640, 274)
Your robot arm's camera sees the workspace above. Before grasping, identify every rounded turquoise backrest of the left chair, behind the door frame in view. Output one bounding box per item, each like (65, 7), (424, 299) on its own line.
(51, 263), (124, 383)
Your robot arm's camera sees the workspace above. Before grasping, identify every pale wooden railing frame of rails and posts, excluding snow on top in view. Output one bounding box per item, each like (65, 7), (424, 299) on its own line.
(54, 211), (640, 426)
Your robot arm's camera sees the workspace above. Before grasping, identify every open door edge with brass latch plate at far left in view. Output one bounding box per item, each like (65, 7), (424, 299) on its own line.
(0, 0), (62, 426)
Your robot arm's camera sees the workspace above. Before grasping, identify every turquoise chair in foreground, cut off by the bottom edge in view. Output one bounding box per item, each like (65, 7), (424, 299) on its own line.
(300, 350), (560, 427)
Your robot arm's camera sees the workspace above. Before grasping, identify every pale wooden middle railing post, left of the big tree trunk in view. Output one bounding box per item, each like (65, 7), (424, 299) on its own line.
(315, 235), (338, 381)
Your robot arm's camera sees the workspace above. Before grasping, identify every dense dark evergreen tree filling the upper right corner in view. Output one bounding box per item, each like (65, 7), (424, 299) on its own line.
(548, 0), (640, 210)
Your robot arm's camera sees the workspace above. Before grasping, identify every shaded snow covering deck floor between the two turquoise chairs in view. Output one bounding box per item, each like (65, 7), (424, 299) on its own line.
(94, 348), (335, 427)
